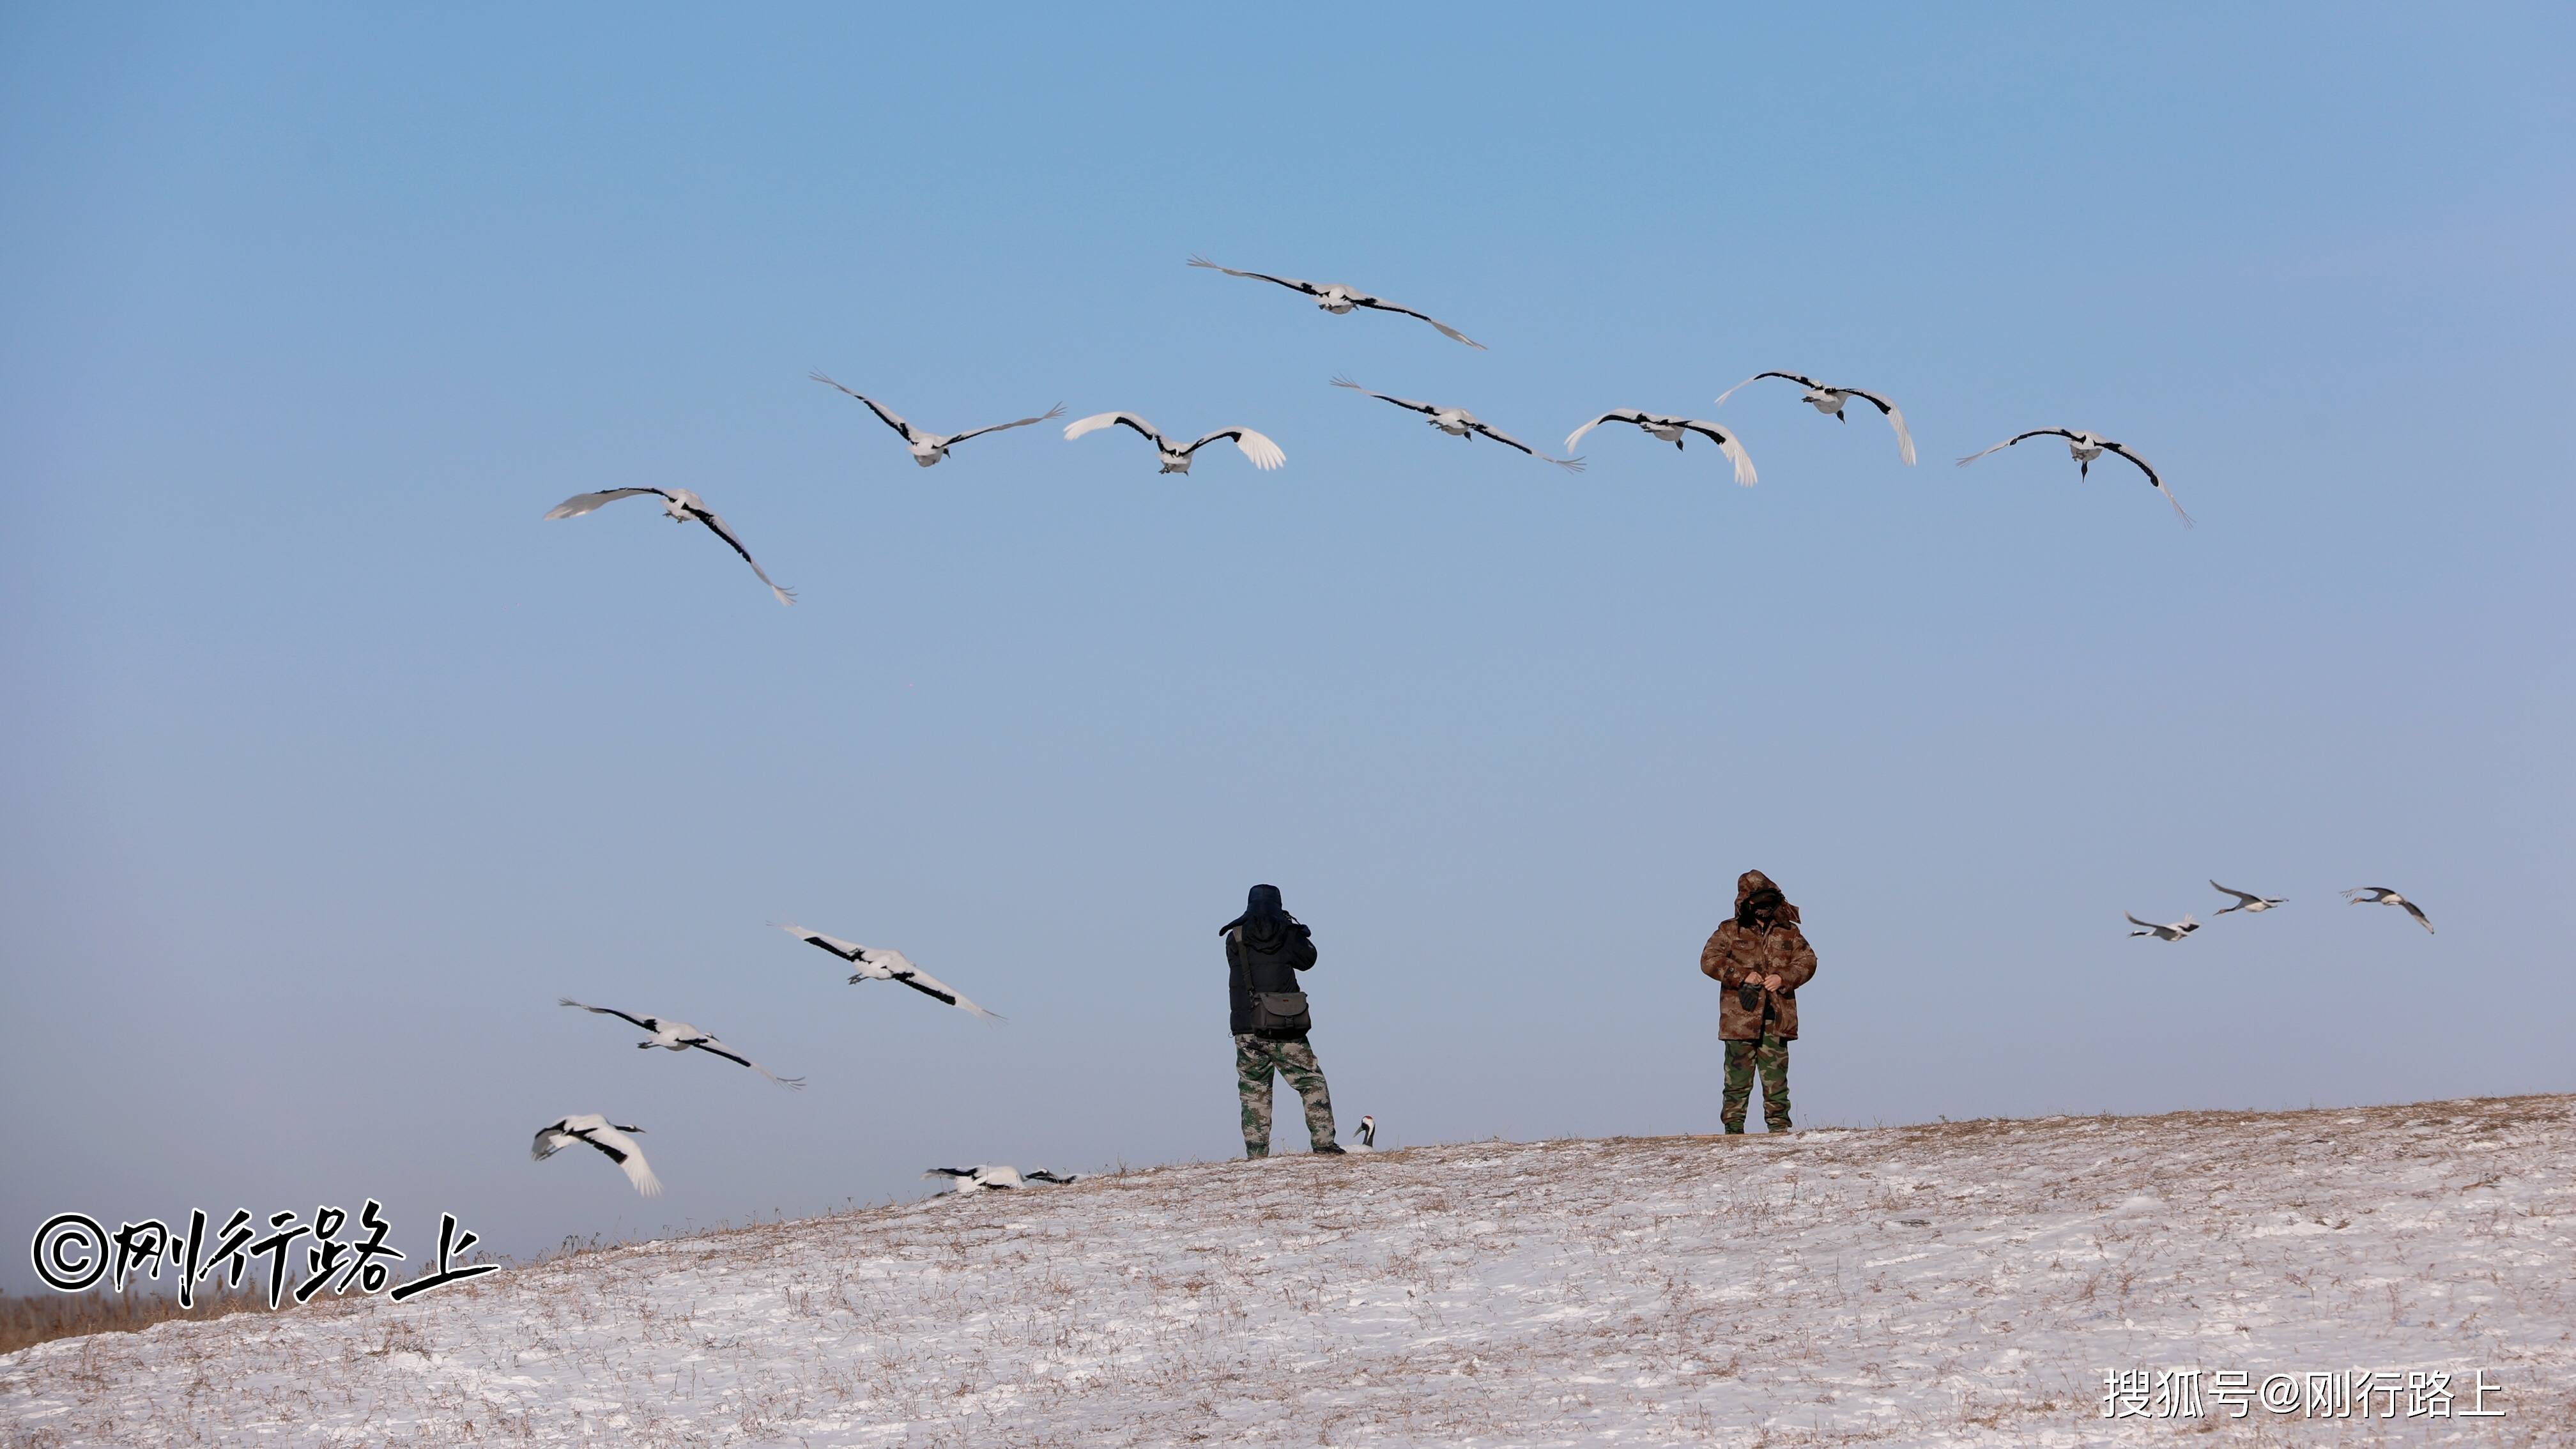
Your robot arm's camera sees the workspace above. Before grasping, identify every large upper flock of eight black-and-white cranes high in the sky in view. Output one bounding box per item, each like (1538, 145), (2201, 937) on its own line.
(546, 256), (2192, 603)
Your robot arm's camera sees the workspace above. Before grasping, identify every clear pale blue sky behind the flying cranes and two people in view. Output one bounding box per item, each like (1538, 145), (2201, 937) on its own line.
(0, 5), (2576, 1287)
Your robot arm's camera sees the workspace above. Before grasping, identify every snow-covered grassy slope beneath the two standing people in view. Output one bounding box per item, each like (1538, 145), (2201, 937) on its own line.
(0, 1096), (2576, 1449)
